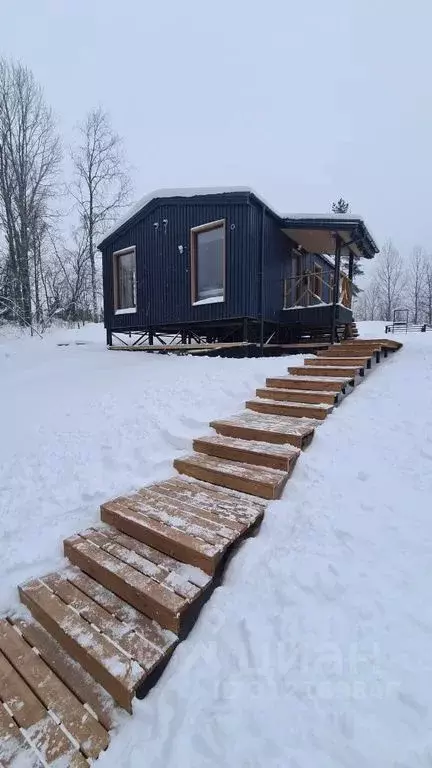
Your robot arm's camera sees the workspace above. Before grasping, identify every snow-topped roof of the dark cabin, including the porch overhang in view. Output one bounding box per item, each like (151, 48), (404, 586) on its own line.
(98, 187), (378, 258)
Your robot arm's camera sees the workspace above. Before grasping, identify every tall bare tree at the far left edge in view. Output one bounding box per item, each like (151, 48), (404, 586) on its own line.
(0, 59), (61, 324)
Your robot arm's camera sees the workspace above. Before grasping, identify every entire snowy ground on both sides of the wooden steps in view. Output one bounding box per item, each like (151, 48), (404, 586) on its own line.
(0, 323), (432, 768)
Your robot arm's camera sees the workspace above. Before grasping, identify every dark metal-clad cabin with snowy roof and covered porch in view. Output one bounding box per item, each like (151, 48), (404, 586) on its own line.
(99, 189), (378, 352)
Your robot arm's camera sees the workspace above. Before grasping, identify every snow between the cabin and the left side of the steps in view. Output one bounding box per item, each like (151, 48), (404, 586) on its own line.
(0, 325), (296, 615)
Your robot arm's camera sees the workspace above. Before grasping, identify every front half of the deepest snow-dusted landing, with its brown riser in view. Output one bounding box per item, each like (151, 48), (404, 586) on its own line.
(101, 489), (236, 574)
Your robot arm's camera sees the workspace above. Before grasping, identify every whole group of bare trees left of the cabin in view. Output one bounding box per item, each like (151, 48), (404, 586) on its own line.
(0, 59), (132, 329)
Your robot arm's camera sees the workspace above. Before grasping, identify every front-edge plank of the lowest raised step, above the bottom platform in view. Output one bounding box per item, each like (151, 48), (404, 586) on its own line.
(19, 580), (145, 712)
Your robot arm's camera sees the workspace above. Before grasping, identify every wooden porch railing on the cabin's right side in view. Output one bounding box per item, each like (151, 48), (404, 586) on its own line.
(284, 271), (352, 309)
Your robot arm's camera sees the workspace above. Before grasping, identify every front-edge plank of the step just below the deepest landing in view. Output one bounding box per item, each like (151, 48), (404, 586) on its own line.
(64, 536), (188, 634)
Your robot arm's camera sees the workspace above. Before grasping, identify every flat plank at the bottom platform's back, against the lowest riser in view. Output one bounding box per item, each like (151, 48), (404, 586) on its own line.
(14, 618), (116, 730)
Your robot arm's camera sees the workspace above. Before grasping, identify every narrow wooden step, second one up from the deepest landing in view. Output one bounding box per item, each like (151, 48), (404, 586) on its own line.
(193, 435), (300, 474)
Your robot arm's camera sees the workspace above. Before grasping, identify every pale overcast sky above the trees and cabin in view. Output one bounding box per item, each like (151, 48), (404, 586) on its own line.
(0, 0), (432, 251)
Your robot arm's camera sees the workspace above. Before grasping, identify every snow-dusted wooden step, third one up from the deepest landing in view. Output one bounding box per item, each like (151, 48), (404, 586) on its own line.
(210, 410), (318, 449)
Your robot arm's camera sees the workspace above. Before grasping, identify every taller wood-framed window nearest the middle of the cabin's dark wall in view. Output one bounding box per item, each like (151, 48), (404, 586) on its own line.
(191, 220), (225, 304)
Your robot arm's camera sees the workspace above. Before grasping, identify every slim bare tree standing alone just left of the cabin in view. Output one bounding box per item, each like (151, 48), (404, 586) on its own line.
(70, 108), (131, 320)
